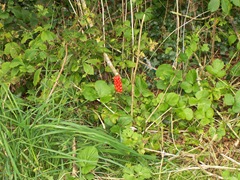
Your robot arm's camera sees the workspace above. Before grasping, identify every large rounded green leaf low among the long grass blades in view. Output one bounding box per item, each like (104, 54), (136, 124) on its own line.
(77, 146), (99, 174)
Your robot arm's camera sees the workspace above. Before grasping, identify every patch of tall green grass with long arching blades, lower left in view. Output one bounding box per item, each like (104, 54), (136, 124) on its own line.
(0, 85), (153, 179)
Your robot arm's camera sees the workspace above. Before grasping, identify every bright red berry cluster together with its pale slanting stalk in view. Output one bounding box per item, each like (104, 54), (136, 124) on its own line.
(103, 53), (122, 93)
